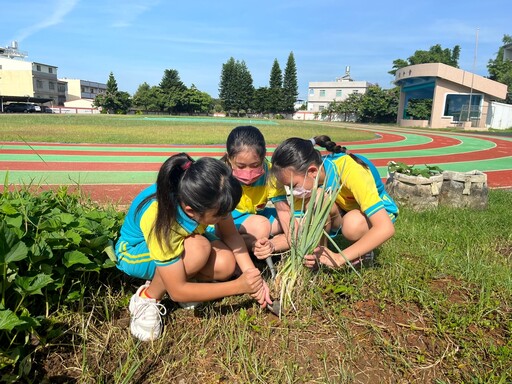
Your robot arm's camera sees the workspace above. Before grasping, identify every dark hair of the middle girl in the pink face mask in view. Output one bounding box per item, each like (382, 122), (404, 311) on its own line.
(221, 125), (267, 163)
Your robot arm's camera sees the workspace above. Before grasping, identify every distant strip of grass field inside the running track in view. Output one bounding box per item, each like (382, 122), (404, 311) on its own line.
(0, 114), (374, 144)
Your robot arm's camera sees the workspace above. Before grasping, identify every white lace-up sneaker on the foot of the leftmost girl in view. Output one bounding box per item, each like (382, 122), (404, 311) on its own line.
(128, 282), (167, 341)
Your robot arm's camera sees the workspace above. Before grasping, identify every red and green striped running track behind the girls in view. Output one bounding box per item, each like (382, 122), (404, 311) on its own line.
(0, 124), (512, 204)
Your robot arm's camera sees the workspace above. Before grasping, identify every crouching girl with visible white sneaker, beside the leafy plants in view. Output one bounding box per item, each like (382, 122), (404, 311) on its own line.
(115, 153), (271, 341)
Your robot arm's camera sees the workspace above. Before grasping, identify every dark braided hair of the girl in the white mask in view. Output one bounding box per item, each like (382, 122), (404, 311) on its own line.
(271, 135), (368, 175)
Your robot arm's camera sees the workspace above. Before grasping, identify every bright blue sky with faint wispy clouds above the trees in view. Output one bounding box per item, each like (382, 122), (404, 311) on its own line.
(0, 0), (512, 99)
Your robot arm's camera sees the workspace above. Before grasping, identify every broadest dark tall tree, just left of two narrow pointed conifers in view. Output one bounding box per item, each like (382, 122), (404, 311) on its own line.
(219, 57), (254, 116)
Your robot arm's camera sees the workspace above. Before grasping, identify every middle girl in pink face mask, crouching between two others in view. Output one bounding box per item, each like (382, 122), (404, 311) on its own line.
(221, 126), (290, 259)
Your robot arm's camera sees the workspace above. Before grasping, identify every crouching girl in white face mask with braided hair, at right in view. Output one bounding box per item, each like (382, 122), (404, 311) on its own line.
(272, 136), (398, 268)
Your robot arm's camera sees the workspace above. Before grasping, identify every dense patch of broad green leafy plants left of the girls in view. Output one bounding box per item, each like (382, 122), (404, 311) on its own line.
(0, 186), (122, 382)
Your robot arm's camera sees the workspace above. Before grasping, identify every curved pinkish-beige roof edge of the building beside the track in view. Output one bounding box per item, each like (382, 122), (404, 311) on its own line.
(395, 63), (507, 99)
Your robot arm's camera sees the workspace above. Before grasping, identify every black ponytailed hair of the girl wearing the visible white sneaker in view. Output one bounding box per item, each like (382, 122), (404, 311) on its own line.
(137, 153), (242, 252)
